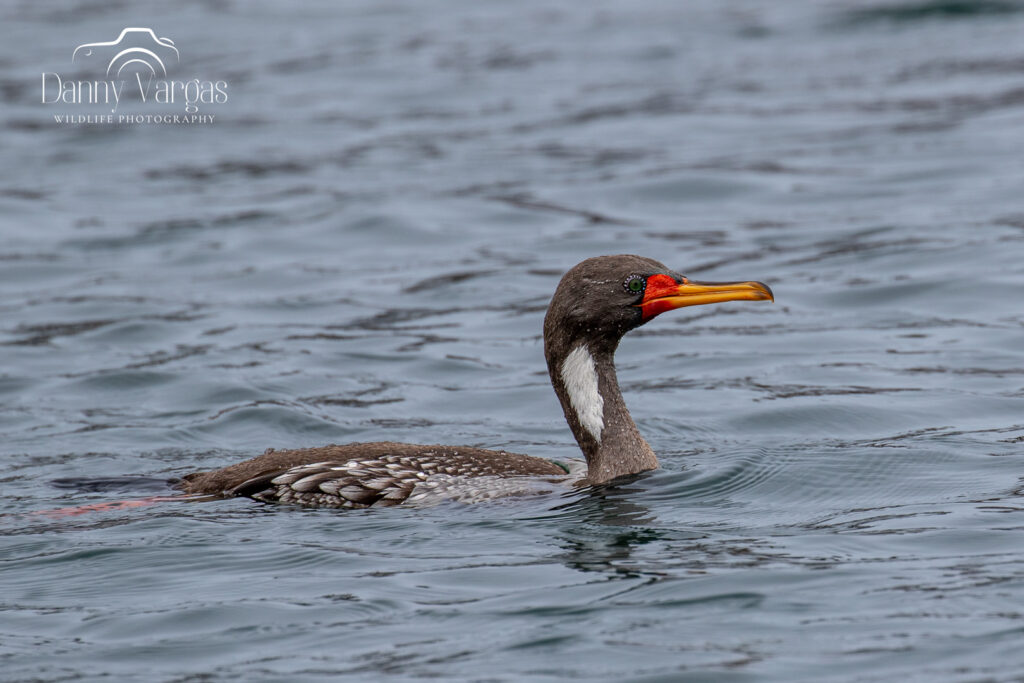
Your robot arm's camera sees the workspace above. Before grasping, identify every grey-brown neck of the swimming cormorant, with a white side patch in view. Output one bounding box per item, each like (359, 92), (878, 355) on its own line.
(548, 342), (657, 484)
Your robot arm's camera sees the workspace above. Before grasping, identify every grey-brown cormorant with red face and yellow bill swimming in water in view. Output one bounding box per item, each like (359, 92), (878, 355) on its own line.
(179, 254), (774, 508)
